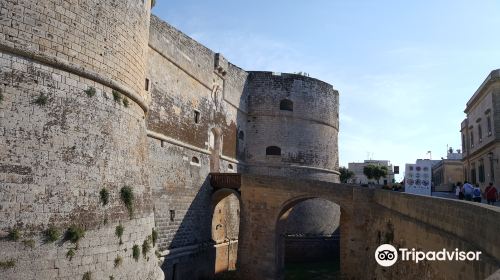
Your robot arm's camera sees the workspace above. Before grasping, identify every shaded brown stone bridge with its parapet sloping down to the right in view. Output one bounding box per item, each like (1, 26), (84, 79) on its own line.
(232, 174), (500, 279)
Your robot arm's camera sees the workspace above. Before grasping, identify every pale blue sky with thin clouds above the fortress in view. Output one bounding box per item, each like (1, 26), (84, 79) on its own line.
(153, 0), (500, 180)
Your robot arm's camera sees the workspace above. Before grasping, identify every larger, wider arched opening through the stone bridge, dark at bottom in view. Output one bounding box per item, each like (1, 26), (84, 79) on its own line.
(276, 198), (341, 279)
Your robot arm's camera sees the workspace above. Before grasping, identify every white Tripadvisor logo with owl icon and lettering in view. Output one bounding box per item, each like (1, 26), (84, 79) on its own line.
(375, 244), (482, 267)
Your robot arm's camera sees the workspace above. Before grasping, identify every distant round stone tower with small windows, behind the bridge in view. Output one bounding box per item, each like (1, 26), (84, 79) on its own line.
(246, 72), (339, 182)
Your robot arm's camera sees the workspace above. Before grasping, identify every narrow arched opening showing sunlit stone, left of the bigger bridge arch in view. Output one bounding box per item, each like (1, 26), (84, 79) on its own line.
(212, 189), (240, 279)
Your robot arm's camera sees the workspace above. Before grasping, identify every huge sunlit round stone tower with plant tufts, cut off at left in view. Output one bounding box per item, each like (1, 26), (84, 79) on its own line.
(0, 0), (161, 279)
